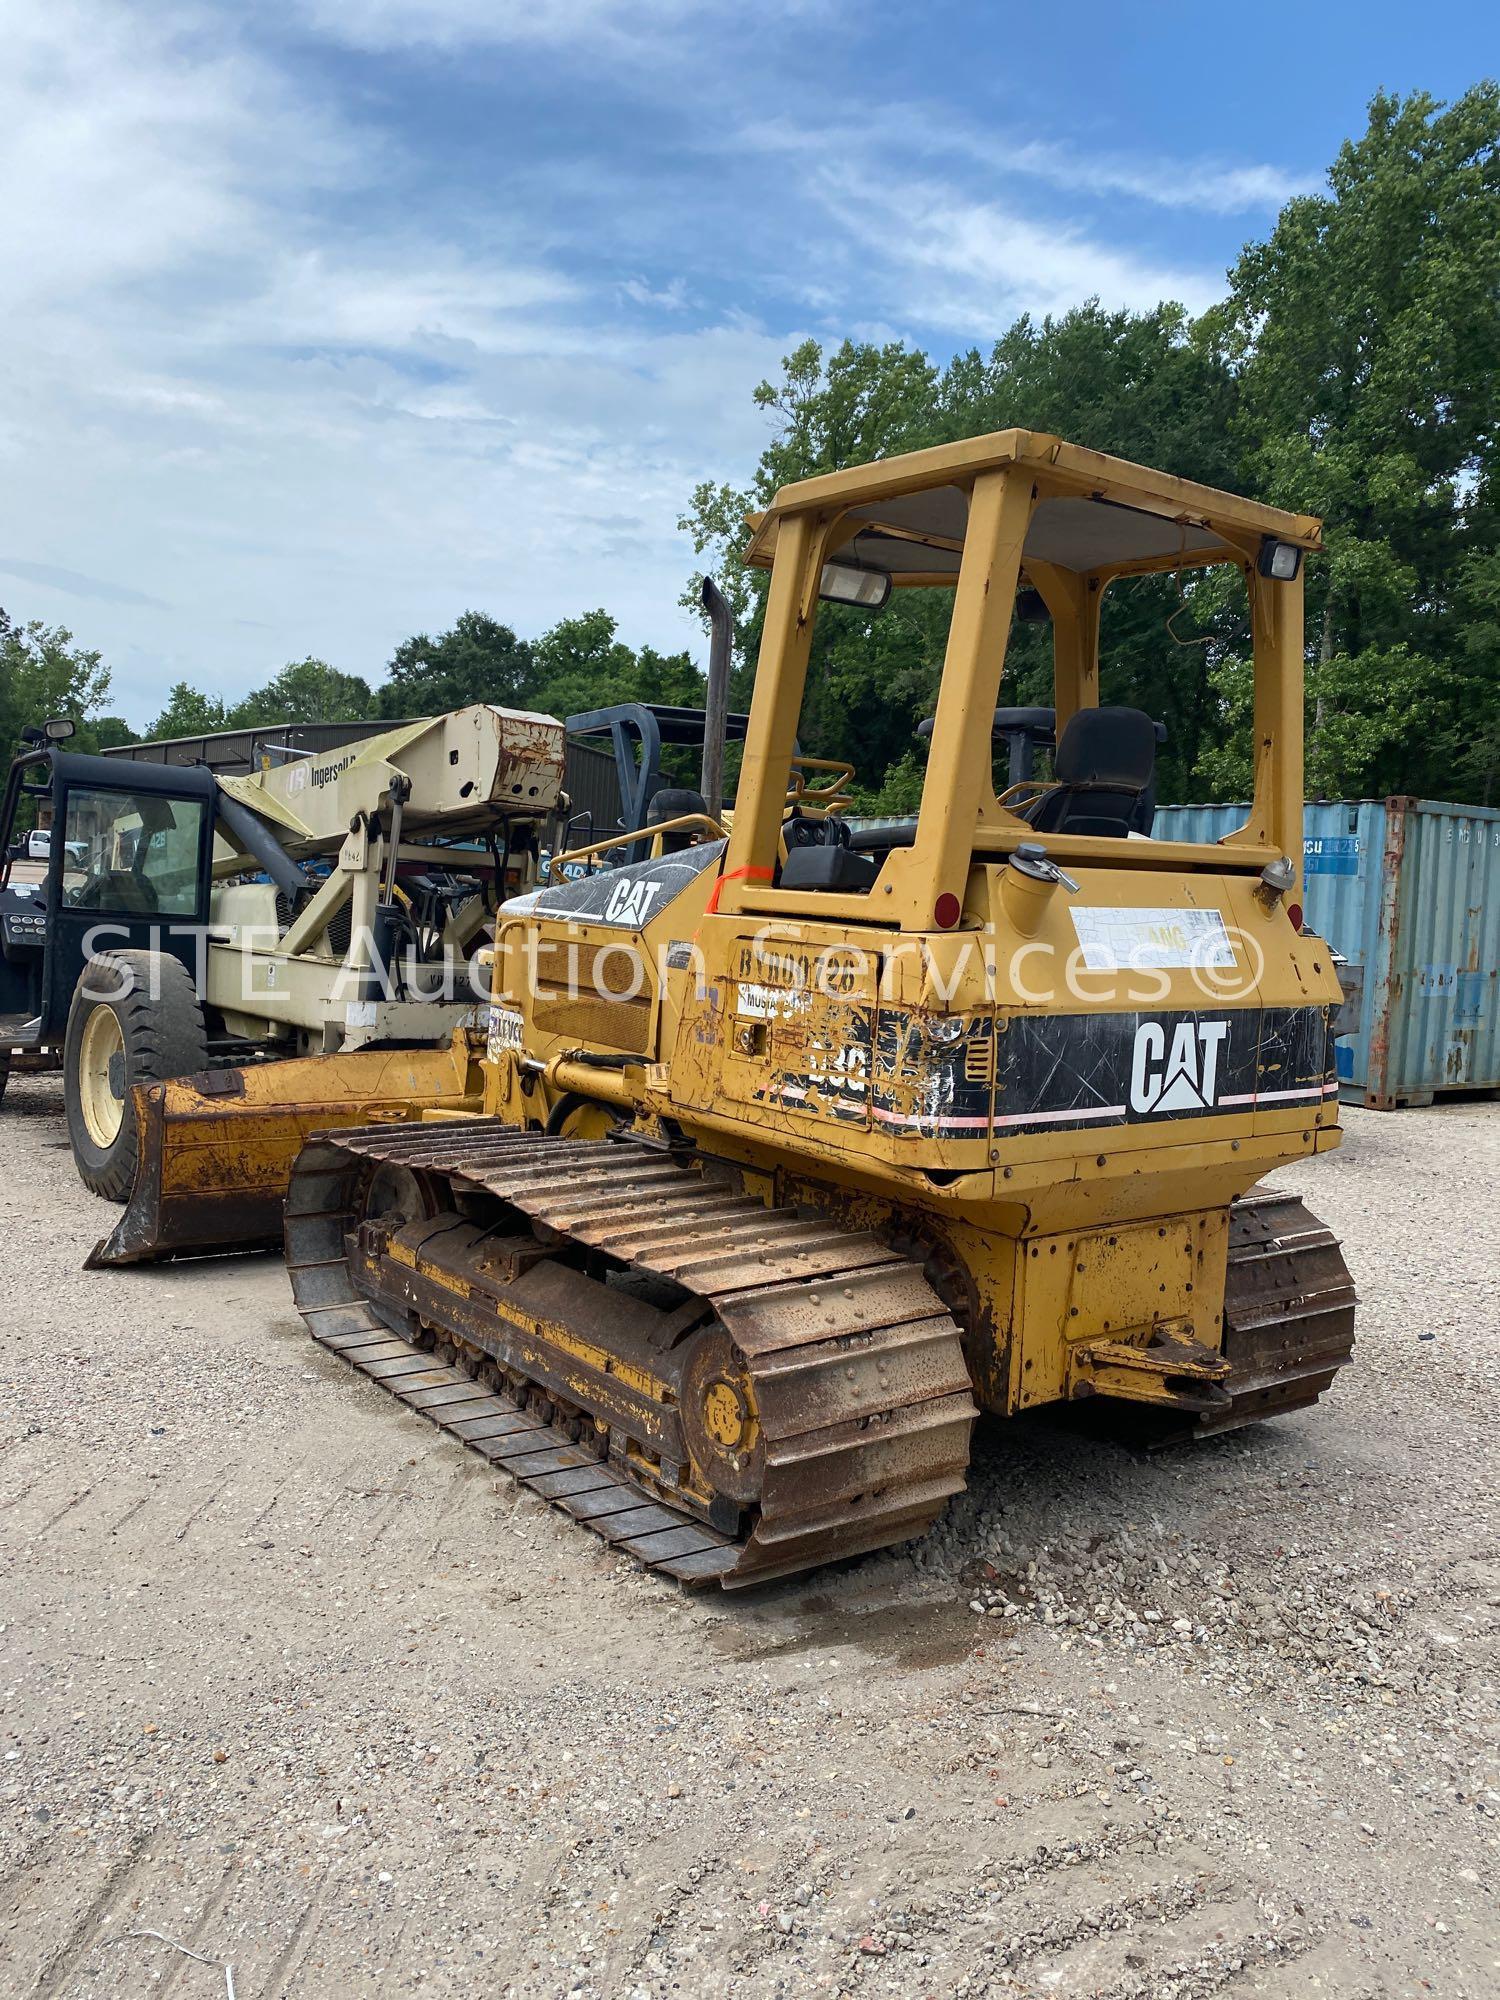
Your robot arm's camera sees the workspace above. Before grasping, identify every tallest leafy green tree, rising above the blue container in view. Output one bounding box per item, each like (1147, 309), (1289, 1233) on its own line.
(1206, 84), (1500, 798)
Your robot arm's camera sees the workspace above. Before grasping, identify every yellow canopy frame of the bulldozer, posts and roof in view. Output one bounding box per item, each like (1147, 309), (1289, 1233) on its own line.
(736, 430), (1322, 932)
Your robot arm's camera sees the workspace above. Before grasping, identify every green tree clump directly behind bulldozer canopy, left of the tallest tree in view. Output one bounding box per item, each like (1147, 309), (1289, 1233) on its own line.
(682, 312), (1242, 808)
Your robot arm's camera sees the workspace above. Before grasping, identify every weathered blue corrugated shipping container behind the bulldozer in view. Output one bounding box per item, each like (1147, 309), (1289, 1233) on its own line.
(1152, 798), (1500, 1110)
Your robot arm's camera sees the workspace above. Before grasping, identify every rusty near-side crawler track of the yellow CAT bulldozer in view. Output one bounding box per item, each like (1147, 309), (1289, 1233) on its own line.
(286, 1120), (976, 1586)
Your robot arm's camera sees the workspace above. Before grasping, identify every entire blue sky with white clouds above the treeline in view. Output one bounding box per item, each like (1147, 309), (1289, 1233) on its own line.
(0, 0), (1500, 724)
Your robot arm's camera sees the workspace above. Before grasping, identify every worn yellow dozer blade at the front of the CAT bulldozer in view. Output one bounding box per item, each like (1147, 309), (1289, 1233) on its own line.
(86, 1030), (482, 1270)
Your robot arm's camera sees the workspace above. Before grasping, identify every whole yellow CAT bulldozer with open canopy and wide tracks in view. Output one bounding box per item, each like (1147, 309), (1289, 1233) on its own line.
(97, 430), (1354, 1586)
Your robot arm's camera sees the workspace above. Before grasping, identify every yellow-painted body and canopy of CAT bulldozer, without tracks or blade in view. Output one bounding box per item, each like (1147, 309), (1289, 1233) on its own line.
(476, 430), (1340, 1412)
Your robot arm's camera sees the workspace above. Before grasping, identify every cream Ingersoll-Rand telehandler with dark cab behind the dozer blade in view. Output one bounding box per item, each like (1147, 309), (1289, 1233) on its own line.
(0, 706), (564, 1242)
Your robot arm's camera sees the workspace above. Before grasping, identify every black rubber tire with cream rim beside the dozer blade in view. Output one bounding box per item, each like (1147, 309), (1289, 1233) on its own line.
(62, 952), (208, 1202)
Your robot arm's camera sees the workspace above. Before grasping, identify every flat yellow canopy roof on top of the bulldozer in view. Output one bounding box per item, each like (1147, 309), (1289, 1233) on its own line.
(746, 430), (1320, 584)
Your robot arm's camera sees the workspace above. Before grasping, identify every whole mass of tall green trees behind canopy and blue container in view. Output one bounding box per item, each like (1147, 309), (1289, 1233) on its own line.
(682, 84), (1500, 810)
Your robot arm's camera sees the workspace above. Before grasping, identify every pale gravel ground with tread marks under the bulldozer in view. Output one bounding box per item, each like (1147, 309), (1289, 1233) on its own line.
(0, 1078), (1500, 2000)
